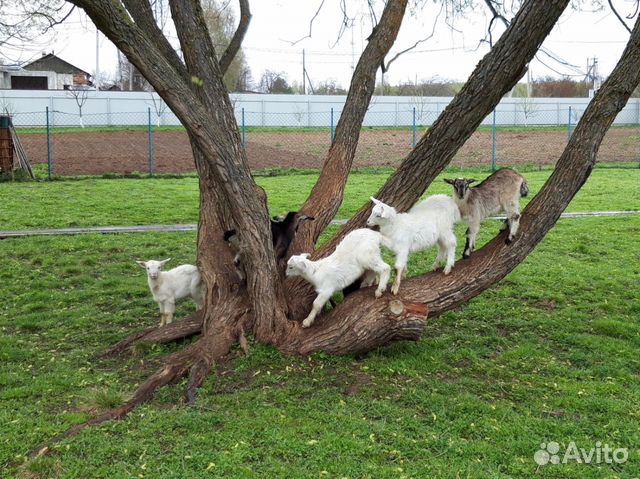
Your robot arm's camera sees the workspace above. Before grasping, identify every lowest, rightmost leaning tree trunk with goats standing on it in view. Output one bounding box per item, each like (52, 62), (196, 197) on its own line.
(282, 13), (640, 354)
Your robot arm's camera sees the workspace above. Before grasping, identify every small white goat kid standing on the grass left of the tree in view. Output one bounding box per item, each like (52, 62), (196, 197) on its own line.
(136, 258), (204, 326)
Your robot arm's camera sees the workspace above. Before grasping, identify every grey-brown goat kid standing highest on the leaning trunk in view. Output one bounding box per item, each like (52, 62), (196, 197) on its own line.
(444, 168), (529, 258)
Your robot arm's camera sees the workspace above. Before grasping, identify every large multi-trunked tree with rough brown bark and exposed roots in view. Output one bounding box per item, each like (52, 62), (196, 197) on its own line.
(8, 0), (640, 450)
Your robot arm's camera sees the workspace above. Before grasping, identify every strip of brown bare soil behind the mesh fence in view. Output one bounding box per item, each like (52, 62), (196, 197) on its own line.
(20, 128), (639, 176)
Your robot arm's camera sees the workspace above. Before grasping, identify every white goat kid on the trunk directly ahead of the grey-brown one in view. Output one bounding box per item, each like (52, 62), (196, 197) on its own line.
(367, 195), (460, 294)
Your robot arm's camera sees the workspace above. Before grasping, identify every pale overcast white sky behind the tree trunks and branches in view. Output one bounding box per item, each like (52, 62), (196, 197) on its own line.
(8, 0), (634, 87)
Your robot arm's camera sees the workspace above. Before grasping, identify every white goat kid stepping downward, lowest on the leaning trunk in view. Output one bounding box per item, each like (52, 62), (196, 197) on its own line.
(286, 228), (391, 328)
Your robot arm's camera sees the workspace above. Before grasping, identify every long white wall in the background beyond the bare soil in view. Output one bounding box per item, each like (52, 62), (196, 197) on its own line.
(0, 90), (640, 128)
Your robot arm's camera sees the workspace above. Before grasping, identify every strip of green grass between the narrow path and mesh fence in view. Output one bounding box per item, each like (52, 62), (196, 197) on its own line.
(0, 167), (640, 230)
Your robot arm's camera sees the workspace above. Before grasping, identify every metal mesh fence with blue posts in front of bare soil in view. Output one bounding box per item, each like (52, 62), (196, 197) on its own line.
(6, 101), (640, 176)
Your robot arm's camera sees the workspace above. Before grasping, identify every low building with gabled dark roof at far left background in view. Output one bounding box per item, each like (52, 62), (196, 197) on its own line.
(0, 53), (93, 90)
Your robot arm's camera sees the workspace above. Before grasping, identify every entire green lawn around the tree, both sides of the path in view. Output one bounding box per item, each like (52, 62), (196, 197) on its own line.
(0, 168), (640, 479)
